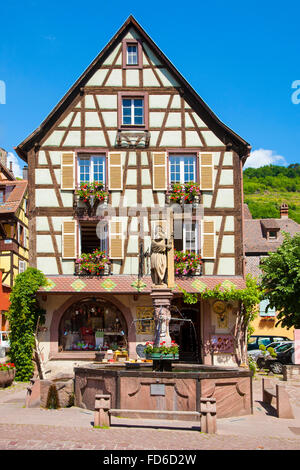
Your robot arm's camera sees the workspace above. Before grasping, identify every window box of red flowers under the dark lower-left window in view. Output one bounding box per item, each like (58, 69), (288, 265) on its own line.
(76, 249), (110, 276)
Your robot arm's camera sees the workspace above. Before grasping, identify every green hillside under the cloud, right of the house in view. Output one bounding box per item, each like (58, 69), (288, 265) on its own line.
(244, 163), (300, 224)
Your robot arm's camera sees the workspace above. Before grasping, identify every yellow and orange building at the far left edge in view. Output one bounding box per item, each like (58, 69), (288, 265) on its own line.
(0, 148), (29, 346)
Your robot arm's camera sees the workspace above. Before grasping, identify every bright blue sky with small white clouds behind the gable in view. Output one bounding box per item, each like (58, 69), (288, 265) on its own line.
(0, 0), (300, 176)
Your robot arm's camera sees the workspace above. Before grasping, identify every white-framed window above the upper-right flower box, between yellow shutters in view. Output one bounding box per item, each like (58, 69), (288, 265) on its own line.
(169, 155), (196, 184)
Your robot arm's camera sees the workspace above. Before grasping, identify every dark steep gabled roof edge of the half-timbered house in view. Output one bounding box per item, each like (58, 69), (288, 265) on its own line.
(15, 15), (251, 161)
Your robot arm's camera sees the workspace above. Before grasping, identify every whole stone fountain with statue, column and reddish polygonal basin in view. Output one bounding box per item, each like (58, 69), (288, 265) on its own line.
(74, 226), (252, 418)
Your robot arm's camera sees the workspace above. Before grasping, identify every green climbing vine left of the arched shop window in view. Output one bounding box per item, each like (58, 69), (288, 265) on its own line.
(7, 268), (47, 381)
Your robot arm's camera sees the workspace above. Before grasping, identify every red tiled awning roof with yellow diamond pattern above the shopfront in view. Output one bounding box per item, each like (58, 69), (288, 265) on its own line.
(39, 275), (246, 294)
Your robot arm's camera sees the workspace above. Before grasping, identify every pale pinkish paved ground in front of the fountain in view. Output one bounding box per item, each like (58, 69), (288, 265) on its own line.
(0, 378), (300, 450)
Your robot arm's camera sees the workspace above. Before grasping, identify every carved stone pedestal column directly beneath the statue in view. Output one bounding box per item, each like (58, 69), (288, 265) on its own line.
(150, 287), (173, 346)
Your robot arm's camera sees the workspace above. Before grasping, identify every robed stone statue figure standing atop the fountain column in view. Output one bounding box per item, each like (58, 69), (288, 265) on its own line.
(151, 225), (172, 287)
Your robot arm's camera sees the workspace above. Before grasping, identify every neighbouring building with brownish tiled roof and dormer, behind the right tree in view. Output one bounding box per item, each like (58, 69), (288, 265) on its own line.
(244, 203), (300, 339)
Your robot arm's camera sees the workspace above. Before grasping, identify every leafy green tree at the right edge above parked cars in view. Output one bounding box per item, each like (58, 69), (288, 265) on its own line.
(261, 232), (300, 328)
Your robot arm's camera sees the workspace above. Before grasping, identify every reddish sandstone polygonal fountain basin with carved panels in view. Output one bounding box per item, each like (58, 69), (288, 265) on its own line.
(74, 363), (253, 418)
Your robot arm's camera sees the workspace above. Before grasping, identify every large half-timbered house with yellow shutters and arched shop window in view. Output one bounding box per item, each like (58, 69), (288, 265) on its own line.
(16, 16), (250, 373)
